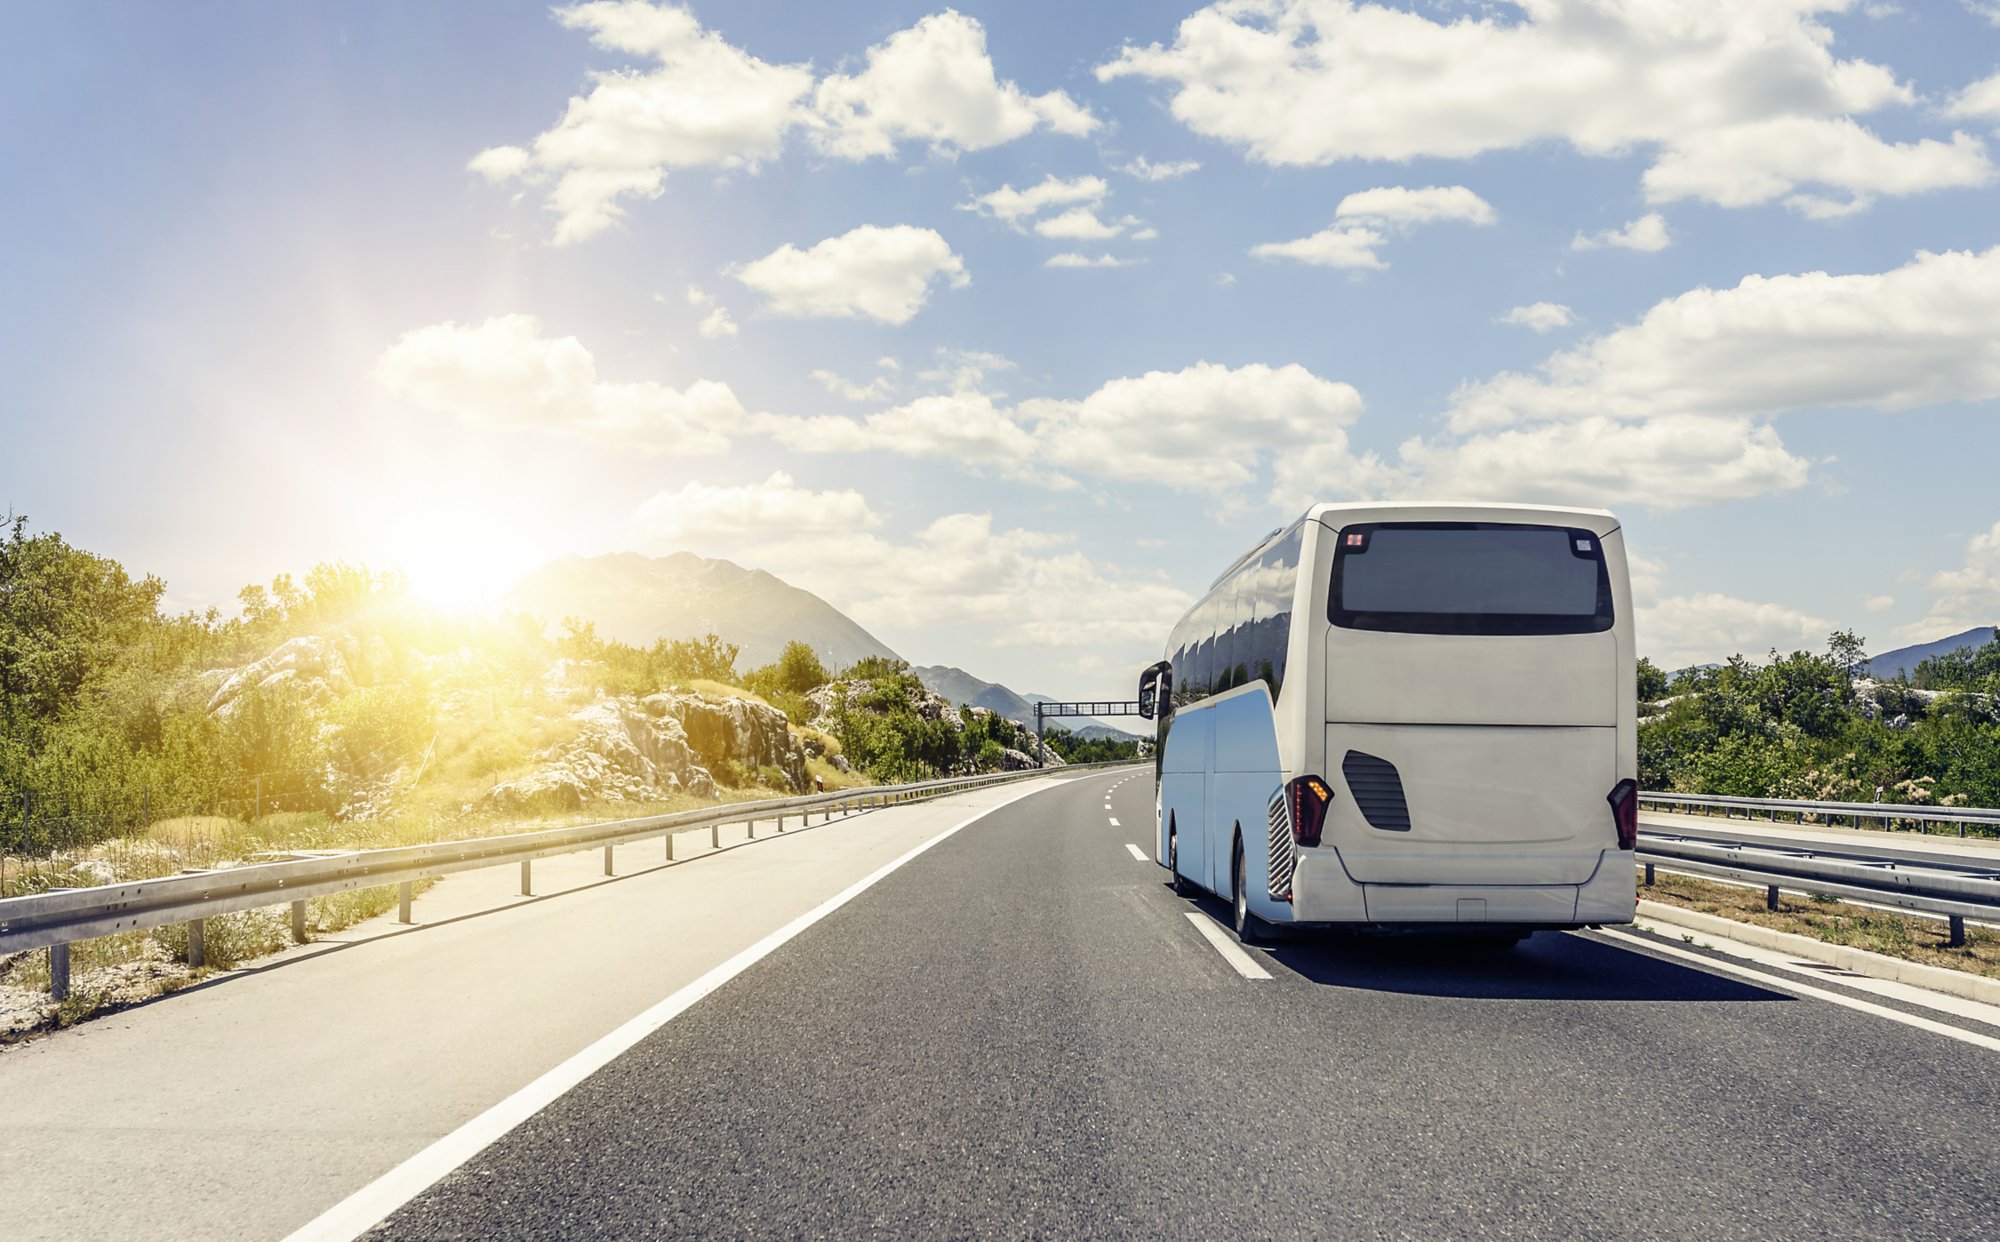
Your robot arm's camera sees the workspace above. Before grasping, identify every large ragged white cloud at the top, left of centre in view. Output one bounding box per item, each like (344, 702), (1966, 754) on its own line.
(470, 0), (1098, 246)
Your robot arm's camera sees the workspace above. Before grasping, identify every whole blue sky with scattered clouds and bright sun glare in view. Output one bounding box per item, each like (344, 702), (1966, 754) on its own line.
(0, 0), (2000, 694)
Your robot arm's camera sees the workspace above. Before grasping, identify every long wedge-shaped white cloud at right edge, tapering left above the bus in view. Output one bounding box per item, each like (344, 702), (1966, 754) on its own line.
(1450, 246), (2000, 430)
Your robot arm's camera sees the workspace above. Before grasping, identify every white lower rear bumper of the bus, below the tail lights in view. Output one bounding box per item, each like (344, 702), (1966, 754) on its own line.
(1292, 846), (1636, 928)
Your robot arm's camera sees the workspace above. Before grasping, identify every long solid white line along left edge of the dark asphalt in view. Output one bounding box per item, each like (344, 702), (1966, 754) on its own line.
(286, 786), (1064, 1242)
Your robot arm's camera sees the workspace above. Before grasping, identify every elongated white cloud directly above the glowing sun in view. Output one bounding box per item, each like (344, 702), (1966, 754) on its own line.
(374, 314), (748, 454)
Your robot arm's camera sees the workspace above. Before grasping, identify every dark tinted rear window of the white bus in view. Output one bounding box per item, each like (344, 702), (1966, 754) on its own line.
(1330, 522), (1612, 634)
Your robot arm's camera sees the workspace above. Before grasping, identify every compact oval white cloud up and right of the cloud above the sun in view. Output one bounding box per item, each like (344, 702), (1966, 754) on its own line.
(734, 224), (972, 324)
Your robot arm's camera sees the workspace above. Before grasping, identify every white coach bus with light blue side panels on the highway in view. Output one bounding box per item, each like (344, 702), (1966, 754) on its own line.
(1140, 504), (1638, 944)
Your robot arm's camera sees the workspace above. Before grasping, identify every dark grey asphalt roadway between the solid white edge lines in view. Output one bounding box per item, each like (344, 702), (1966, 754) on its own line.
(378, 772), (2000, 1238)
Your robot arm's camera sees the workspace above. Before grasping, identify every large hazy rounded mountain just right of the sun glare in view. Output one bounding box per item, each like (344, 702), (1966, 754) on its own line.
(504, 552), (896, 668)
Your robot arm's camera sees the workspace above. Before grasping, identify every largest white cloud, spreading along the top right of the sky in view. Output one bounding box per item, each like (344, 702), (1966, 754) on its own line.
(1096, 0), (1994, 206)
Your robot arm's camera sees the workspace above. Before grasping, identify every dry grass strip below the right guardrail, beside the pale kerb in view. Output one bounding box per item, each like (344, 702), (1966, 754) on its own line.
(1638, 870), (2000, 978)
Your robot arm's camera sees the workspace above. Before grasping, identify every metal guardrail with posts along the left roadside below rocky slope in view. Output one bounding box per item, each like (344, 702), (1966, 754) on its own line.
(0, 760), (1128, 1000)
